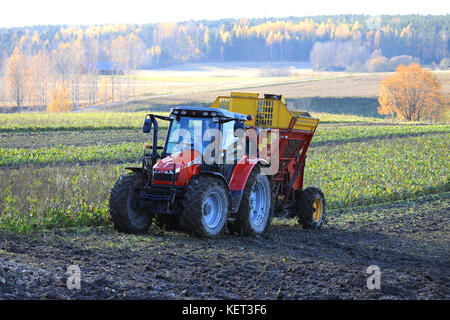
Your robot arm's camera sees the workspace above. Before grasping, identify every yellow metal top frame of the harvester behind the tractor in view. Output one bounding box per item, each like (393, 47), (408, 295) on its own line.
(210, 92), (319, 132)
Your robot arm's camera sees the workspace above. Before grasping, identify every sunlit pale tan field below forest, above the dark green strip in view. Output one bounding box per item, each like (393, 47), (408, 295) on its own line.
(131, 62), (450, 98)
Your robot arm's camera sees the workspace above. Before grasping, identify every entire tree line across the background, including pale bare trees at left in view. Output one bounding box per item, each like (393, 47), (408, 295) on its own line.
(0, 15), (450, 110)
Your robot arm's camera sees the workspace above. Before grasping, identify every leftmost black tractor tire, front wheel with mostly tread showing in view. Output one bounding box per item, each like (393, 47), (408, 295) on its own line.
(109, 173), (153, 234)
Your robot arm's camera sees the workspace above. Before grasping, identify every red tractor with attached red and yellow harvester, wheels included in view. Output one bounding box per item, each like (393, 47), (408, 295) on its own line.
(109, 93), (325, 237)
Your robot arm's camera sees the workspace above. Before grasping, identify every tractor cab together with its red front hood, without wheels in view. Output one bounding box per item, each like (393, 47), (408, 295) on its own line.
(143, 107), (251, 186)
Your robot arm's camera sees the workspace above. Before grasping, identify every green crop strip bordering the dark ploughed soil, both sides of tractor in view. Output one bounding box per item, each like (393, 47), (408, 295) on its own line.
(0, 134), (450, 232)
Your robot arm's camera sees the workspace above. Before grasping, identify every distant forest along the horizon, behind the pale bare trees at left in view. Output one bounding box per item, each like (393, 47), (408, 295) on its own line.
(0, 15), (449, 68)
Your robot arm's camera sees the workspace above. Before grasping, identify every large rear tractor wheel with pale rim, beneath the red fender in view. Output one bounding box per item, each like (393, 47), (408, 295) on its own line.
(230, 167), (273, 236)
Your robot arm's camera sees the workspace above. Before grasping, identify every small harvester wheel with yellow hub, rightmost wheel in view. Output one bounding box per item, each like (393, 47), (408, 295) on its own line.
(296, 187), (325, 229)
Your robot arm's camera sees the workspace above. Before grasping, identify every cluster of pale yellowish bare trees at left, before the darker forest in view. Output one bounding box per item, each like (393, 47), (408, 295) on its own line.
(0, 32), (145, 112)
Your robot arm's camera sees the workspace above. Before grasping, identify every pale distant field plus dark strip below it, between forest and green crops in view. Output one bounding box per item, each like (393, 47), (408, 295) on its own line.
(92, 62), (450, 117)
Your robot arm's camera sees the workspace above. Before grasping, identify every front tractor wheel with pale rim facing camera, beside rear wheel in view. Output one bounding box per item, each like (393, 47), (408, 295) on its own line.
(180, 176), (230, 238)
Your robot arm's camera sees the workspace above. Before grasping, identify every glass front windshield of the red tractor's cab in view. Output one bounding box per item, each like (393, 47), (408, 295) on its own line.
(166, 117), (219, 155)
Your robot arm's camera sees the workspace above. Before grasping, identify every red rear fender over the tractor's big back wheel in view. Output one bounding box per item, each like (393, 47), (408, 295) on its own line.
(230, 156), (269, 213)
